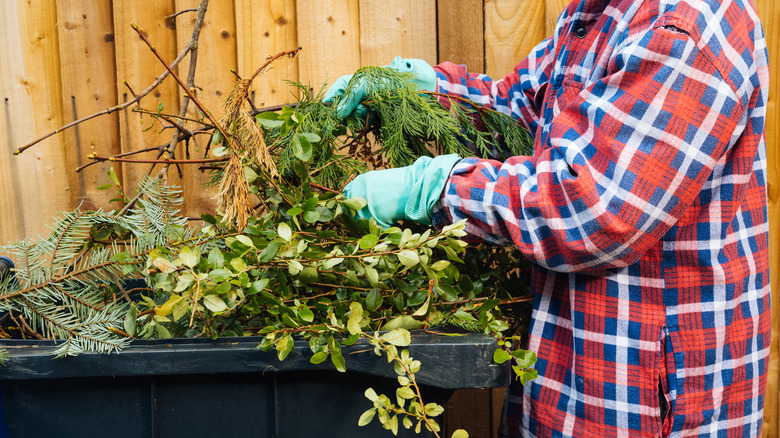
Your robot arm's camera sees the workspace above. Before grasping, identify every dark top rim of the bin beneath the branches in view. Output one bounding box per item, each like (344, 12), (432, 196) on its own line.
(0, 330), (507, 389)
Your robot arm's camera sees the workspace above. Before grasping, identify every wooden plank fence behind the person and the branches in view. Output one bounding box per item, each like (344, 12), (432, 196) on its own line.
(0, 0), (780, 437)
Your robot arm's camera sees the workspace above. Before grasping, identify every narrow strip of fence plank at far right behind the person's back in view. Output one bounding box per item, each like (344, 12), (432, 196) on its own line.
(755, 0), (780, 437)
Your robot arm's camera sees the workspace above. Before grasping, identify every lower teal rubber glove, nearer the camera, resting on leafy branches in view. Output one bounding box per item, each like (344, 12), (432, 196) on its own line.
(344, 154), (460, 229)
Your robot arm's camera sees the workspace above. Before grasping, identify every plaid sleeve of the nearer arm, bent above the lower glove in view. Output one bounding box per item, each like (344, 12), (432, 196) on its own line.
(434, 27), (750, 271)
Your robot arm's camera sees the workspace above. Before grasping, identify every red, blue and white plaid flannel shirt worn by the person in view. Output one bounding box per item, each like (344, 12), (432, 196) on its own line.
(434, 0), (770, 437)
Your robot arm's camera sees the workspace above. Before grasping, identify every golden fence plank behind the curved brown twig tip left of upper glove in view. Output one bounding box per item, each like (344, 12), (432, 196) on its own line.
(236, 0), (298, 108)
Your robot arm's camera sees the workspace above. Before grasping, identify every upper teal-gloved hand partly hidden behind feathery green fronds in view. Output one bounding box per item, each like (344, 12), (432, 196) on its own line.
(322, 56), (436, 118)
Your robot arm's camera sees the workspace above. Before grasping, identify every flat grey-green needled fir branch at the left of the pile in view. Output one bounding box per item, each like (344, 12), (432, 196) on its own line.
(0, 178), (192, 356)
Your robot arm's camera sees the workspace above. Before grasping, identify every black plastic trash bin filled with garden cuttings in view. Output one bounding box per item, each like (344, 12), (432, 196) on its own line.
(0, 332), (506, 438)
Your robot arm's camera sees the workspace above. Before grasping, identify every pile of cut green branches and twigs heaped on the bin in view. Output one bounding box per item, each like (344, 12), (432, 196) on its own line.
(0, 1), (535, 431)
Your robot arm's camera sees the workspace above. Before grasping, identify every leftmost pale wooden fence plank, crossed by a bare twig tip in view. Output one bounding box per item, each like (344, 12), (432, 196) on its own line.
(0, 1), (72, 245)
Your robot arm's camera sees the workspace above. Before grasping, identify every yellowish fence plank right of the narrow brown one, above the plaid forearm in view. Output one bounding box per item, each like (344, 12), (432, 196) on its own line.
(485, 0), (547, 78)
